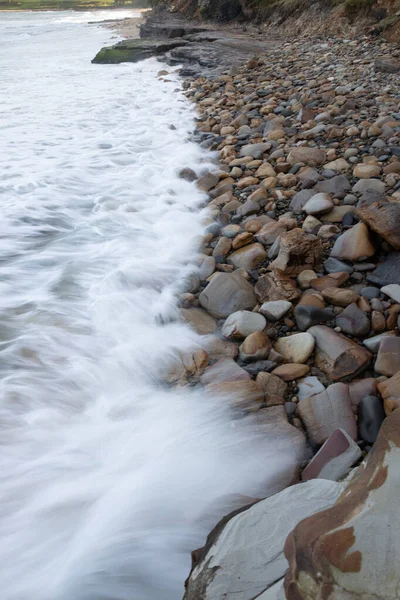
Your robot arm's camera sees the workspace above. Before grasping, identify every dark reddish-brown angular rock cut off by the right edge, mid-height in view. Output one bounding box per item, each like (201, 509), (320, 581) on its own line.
(357, 201), (400, 250)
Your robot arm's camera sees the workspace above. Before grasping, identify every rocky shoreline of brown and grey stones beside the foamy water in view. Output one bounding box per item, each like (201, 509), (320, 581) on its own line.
(97, 12), (400, 600)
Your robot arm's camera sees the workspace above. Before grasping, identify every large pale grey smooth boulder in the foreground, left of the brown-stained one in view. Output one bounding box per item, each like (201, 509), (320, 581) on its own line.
(184, 480), (342, 600)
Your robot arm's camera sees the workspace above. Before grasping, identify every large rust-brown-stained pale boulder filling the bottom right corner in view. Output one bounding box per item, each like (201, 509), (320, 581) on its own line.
(285, 411), (400, 600)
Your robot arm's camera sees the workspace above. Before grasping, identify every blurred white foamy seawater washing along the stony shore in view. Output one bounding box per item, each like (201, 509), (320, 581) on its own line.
(0, 13), (282, 600)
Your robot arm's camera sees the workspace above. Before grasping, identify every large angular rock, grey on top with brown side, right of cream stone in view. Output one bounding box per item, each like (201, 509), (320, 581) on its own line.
(308, 325), (372, 381)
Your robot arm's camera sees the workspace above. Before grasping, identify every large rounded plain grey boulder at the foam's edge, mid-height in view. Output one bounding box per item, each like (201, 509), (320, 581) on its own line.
(199, 271), (257, 319)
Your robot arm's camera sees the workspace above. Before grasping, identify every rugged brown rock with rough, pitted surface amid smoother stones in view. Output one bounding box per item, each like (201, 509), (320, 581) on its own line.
(269, 228), (322, 277)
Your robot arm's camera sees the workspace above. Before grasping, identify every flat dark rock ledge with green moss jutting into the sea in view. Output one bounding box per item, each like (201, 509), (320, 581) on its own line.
(92, 39), (189, 64)
